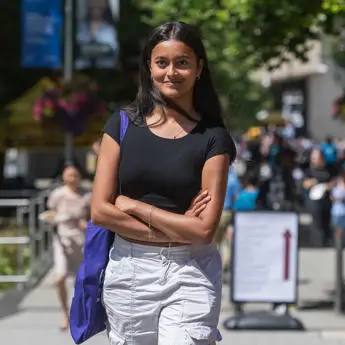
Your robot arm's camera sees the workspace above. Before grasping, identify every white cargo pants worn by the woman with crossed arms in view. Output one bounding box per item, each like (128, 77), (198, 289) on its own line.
(103, 235), (222, 345)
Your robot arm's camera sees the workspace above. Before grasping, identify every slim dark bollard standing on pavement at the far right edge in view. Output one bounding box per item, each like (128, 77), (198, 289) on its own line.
(334, 229), (344, 313)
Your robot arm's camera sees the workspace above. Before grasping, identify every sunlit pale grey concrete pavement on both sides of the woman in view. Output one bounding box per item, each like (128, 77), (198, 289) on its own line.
(0, 249), (345, 345)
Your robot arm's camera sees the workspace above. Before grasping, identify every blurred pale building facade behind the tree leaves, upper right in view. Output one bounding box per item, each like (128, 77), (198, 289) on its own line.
(253, 40), (345, 140)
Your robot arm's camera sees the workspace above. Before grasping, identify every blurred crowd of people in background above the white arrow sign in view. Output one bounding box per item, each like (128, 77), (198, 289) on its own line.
(217, 131), (345, 255)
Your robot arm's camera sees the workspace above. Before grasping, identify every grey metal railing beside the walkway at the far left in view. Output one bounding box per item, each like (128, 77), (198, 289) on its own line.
(0, 184), (57, 287)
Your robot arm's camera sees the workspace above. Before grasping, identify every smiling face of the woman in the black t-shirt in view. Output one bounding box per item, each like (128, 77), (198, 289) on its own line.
(150, 40), (203, 99)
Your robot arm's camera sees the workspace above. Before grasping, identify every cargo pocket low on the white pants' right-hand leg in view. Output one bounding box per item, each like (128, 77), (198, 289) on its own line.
(185, 326), (222, 345)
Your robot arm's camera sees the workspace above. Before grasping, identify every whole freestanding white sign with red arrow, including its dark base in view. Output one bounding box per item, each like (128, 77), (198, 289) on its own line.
(223, 211), (304, 331)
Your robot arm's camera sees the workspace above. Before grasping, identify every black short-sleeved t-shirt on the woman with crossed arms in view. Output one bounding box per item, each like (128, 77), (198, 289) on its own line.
(104, 114), (236, 214)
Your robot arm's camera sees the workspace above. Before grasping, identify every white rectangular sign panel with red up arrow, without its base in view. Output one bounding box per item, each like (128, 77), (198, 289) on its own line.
(232, 211), (298, 303)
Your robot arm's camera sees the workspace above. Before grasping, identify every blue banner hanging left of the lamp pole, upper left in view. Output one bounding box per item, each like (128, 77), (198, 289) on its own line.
(21, 0), (63, 68)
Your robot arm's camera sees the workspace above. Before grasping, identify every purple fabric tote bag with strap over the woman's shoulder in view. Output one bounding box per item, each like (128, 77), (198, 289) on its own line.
(70, 111), (128, 344)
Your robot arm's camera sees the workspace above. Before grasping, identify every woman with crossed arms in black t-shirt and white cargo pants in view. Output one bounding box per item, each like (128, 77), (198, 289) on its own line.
(91, 22), (236, 345)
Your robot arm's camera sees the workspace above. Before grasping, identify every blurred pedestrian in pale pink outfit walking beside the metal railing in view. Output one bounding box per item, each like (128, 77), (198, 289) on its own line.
(47, 166), (90, 330)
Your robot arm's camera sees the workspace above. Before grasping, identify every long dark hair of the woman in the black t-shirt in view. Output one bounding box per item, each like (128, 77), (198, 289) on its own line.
(125, 21), (223, 125)
